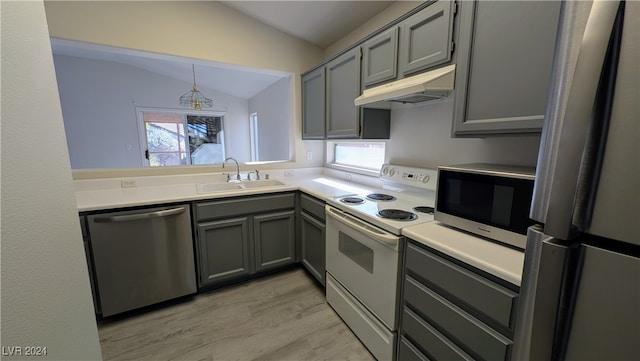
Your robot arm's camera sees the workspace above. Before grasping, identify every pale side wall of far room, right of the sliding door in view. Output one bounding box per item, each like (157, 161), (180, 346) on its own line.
(249, 77), (291, 160)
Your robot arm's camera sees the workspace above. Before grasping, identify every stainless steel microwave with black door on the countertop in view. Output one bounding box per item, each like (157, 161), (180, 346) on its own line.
(435, 163), (535, 249)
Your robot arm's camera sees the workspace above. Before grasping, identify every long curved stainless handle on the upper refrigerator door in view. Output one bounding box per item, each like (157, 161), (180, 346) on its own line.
(531, 1), (620, 239)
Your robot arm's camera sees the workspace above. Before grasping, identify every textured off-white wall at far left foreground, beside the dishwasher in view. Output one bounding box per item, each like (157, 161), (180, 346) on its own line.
(0, 1), (101, 360)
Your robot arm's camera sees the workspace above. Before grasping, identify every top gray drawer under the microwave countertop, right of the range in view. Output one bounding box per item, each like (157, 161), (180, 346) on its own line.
(407, 244), (518, 330)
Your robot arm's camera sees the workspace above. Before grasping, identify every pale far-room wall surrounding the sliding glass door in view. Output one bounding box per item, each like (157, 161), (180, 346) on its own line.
(54, 55), (251, 169)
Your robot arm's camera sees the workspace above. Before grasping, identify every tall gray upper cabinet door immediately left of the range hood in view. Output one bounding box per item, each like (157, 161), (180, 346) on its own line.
(326, 47), (360, 138)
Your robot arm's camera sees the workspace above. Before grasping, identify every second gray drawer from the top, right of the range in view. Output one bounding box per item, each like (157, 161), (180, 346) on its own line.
(403, 276), (512, 360)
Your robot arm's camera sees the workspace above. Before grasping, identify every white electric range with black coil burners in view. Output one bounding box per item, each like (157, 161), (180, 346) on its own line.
(325, 164), (438, 360)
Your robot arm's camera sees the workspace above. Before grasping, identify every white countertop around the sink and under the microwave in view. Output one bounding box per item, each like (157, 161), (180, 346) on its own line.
(75, 170), (524, 286)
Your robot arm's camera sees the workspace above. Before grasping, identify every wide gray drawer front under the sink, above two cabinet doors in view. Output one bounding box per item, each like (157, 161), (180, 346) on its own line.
(195, 193), (295, 221)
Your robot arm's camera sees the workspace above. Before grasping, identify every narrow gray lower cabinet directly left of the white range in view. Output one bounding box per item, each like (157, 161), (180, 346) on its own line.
(300, 194), (326, 286)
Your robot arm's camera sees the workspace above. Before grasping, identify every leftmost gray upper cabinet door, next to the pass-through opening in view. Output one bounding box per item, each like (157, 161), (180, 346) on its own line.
(302, 67), (325, 139)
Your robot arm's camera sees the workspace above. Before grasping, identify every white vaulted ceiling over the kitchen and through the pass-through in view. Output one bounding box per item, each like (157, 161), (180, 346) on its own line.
(52, 1), (394, 99)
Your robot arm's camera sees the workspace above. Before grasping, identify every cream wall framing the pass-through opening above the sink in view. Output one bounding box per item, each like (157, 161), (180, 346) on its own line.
(45, 1), (323, 177)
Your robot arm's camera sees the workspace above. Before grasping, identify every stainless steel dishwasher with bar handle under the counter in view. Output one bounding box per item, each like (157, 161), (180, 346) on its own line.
(87, 204), (196, 317)
